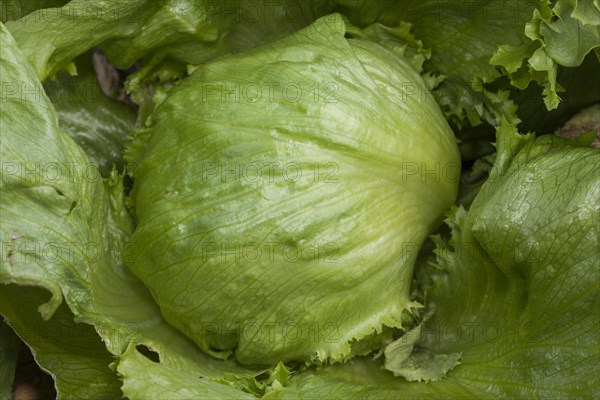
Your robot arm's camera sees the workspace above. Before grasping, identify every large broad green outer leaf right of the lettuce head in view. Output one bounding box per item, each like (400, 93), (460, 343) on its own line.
(265, 124), (600, 399)
